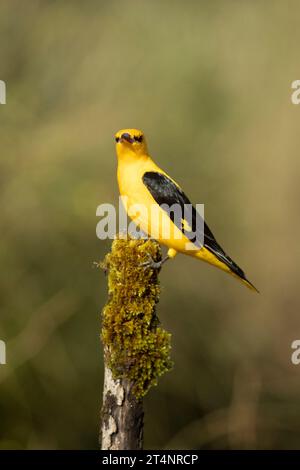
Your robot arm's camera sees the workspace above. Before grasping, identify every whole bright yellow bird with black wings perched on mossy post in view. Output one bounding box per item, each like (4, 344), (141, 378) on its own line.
(115, 129), (258, 292)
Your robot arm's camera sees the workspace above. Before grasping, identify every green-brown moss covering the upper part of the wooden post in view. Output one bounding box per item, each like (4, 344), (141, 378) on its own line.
(101, 238), (172, 398)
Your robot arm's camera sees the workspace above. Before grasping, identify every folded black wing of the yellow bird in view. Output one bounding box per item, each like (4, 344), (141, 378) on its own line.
(143, 171), (245, 279)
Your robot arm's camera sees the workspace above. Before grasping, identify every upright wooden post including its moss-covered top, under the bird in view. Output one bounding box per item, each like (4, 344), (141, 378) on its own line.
(100, 238), (172, 450)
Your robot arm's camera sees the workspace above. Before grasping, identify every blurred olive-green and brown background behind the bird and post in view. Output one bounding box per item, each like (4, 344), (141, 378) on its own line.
(0, 0), (300, 449)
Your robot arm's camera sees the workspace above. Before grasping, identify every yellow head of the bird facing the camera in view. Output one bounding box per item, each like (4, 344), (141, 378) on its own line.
(115, 129), (148, 157)
